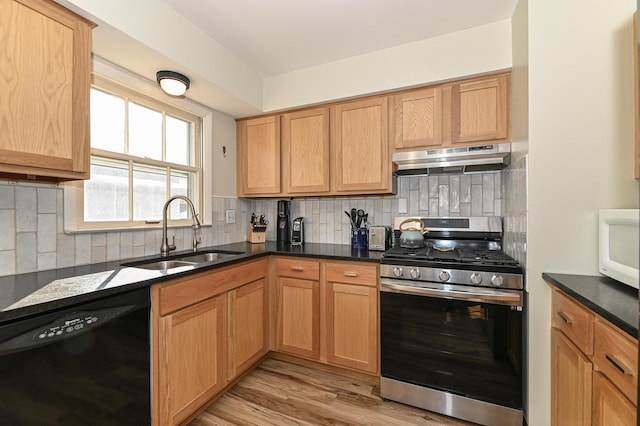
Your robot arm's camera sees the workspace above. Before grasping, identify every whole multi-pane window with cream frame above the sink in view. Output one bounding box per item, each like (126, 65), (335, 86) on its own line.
(76, 76), (203, 229)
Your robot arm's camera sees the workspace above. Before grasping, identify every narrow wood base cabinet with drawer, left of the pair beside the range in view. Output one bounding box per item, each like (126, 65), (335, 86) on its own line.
(275, 258), (320, 360)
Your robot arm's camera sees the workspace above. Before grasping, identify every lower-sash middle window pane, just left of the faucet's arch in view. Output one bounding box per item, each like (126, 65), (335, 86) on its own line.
(133, 164), (167, 220)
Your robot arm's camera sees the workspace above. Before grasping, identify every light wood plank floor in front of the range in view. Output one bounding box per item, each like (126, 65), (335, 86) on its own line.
(190, 359), (471, 426)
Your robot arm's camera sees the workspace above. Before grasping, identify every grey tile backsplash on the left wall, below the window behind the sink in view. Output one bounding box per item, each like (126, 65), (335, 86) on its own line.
(0, 184), (252, 276)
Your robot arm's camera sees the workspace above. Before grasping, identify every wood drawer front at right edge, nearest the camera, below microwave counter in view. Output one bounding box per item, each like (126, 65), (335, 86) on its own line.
(593, 319), (638, 401)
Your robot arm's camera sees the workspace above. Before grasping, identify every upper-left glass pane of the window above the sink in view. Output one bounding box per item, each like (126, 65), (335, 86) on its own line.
(90, 88), (125, 153)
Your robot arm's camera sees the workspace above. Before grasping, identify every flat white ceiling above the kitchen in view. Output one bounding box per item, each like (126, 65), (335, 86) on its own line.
(164, 0), (517, 77)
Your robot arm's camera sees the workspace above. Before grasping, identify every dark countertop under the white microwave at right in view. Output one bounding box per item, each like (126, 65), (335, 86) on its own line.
(542, 272), (638, 338)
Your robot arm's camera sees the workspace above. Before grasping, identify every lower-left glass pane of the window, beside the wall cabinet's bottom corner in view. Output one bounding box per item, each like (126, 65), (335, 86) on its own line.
(84, 157), (129, 222)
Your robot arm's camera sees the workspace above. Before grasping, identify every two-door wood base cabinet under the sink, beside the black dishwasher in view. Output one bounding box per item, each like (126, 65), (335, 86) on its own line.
(152, 259), (268, 425)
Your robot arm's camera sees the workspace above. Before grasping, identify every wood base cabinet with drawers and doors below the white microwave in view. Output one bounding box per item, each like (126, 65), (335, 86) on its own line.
(551, 290), (638, 426)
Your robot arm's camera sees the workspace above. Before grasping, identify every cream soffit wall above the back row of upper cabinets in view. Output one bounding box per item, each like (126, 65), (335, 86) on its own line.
(263, 20), (511, 111)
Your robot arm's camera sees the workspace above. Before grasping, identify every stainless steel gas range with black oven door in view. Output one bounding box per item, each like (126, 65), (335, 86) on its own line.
(380, 217), (525, 426)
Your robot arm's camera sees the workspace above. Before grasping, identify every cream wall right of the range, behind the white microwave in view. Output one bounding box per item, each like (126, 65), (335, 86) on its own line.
(527, 0), (638, 426)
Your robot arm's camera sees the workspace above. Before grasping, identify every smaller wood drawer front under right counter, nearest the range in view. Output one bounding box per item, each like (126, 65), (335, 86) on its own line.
(551, 290), (594, 355)
